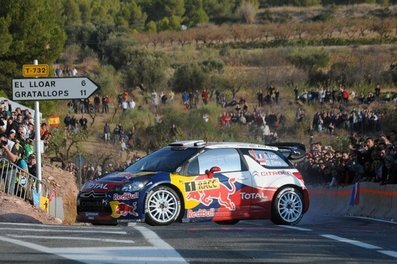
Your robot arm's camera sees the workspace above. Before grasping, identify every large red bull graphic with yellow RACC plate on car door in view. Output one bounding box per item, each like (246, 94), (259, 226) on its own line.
(185, 175), (236, 211)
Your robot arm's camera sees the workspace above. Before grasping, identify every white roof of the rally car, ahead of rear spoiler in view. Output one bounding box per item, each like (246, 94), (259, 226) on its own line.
(168, 140), (278, 150)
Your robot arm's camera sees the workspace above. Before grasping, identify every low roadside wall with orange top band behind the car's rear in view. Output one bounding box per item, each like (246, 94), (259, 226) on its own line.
(308, 182), (397, 222)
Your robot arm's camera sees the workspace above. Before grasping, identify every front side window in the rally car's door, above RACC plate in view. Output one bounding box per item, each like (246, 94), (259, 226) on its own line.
(196, 148), (241, 174)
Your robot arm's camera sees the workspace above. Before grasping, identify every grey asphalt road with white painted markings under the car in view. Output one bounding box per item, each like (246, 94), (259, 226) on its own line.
(0, 214), (397, 264)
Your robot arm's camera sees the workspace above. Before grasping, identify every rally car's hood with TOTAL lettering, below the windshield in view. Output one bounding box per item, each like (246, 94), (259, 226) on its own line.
(80, 172), (158, 192)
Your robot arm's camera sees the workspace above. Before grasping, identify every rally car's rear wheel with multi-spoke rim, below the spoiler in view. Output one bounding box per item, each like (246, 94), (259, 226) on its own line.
(271, 187), (303, 225)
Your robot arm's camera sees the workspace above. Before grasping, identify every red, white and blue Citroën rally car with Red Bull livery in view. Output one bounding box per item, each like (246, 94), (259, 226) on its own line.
(77, 140), (309, 225)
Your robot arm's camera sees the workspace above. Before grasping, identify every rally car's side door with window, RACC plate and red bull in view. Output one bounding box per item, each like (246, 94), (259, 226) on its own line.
(185, 148), (251, 221)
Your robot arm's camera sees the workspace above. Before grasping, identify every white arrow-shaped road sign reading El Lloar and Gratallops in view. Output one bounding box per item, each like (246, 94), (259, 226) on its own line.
(12, 77), (99, 101)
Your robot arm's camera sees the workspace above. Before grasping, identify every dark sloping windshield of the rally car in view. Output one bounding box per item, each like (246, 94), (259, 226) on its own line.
(125, 147), (200, 173)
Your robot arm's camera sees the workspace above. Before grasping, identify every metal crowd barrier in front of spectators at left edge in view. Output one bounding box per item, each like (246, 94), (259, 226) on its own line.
(0, 158), (51, 209)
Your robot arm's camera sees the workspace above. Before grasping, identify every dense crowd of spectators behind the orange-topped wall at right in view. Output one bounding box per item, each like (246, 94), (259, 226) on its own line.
(297, 130), (397, 187)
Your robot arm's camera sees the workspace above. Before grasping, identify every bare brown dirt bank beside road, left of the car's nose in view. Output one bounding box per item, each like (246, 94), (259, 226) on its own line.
(0, 165), (78, 224)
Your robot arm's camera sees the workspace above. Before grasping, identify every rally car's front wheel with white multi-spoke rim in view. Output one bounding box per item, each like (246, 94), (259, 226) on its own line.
(145, 186), (181, 226)
